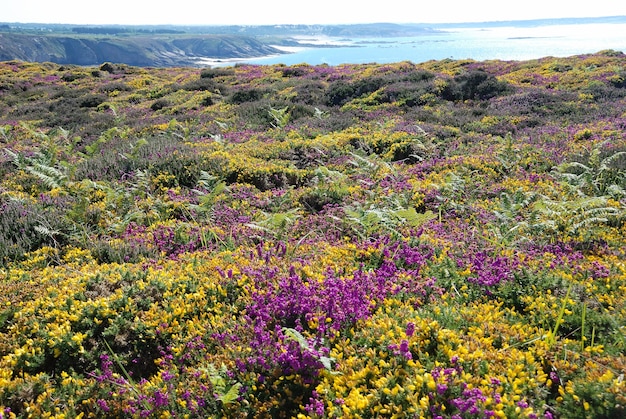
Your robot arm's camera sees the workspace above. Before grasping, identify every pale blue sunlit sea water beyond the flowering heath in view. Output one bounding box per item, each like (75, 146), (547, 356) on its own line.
(245, 23), (626, 65)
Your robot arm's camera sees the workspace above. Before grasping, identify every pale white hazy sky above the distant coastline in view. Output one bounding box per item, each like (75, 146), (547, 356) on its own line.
(0, 0), (626, 25)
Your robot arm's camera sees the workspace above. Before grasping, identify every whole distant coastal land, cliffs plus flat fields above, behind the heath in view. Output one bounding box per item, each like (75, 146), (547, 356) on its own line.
(0, 23), (434, 67)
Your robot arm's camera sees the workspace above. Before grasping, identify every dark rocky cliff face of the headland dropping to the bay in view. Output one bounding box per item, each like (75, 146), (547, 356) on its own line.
(0, 33), (281, 67)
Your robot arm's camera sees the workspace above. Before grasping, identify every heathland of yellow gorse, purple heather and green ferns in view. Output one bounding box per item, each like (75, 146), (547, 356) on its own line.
(0, 50), (626, 418)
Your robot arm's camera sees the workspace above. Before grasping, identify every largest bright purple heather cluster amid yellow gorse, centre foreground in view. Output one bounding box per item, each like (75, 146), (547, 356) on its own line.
(236, 241), (433, 381)
